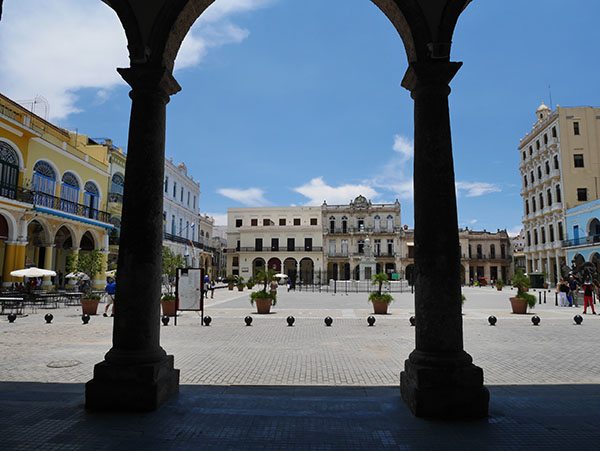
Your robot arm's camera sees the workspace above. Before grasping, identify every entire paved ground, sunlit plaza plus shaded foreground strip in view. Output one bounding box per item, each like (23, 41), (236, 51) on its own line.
(0, 288), (600, 449)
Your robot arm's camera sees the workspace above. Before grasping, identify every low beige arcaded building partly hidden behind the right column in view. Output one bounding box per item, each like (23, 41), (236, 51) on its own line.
(400, 228), (512, 284)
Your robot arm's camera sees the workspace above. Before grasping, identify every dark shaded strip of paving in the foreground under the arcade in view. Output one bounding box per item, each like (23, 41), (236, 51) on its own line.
(0, 382), (600, 450)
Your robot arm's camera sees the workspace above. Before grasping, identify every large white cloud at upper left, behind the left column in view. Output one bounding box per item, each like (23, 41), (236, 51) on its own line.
(0, 0), (272, 120)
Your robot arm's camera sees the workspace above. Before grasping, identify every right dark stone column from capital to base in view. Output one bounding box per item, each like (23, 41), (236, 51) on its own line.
(400, 61), (489, 419)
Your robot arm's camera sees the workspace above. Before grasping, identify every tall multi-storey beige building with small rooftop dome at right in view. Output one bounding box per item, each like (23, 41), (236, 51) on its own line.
(519, 104), (600, 283)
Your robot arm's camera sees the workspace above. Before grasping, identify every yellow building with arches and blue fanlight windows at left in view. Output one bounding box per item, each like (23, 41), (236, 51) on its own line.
(0, 94), (113, 287)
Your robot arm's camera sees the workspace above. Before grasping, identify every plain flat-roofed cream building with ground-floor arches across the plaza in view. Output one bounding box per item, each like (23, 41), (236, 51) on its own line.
(227, 207), (324, 283)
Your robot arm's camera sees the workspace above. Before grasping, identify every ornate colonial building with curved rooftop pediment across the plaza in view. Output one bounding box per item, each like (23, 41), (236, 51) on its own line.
(321, 196), (402, 280)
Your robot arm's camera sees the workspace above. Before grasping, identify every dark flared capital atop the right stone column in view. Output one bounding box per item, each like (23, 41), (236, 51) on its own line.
(401, 61), (463, 95)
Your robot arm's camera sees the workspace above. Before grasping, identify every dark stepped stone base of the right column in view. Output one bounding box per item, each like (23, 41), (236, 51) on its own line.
(400, 359), (490, 420)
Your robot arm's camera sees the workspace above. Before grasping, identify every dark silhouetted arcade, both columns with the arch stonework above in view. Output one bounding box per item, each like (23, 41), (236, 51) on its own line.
(86, 0), (489, 418)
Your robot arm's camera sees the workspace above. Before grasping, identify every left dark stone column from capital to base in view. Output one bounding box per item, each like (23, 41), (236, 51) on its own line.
(86, 65), (180, 411)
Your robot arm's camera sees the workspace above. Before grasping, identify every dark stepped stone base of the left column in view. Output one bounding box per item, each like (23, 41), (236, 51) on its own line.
(85, 355), (179, 412)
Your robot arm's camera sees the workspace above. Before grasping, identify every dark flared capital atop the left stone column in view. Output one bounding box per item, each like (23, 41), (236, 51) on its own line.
(117, 64), (181, 102)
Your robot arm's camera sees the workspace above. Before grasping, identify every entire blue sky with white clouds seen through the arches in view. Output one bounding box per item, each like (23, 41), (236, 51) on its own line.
(0, 0), (600, 232)
